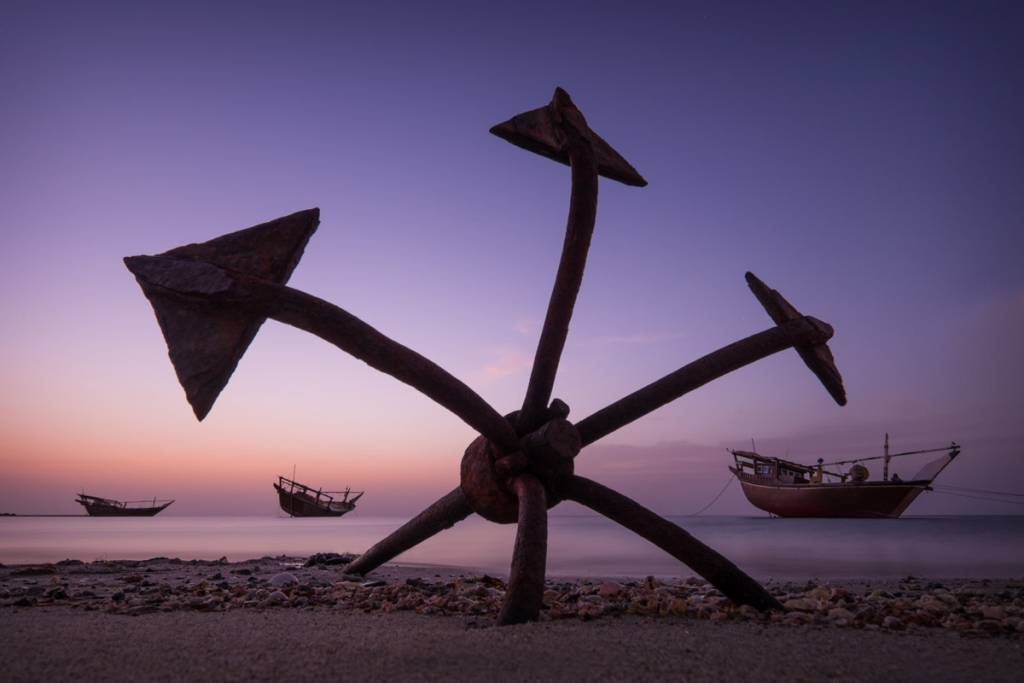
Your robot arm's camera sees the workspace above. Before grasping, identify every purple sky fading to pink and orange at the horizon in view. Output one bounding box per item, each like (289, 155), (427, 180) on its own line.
(0, 0), (1024, 515)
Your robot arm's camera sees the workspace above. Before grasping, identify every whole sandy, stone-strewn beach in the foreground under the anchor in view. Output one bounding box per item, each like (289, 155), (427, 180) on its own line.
(0, 558), (1024, 683)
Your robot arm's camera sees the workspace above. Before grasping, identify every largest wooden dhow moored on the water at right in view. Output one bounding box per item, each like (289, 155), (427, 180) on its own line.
(729, 434), (959, 518)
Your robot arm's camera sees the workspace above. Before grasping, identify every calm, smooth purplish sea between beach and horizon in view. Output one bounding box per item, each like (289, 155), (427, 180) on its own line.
(0, 515), (1024, 581)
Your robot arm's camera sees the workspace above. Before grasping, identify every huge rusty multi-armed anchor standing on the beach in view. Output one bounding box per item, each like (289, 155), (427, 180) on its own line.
(125, 88), (846, 625)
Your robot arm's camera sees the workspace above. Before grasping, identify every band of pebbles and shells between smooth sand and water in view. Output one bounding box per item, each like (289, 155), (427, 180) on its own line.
(0, 557), (1024, 638)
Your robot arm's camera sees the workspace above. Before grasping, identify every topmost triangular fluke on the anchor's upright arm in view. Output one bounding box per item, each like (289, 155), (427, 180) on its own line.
(490, 88), (647, 187)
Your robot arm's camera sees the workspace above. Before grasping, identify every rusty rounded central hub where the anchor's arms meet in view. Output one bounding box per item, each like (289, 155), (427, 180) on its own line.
(460, 400), (583, 524)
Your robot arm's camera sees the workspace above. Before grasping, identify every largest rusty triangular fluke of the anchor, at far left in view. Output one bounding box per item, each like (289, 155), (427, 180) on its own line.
(125, 209), (319, 420)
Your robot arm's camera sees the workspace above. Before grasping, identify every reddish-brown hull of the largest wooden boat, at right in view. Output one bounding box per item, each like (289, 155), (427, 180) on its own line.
(730, 475), (929, 519)
